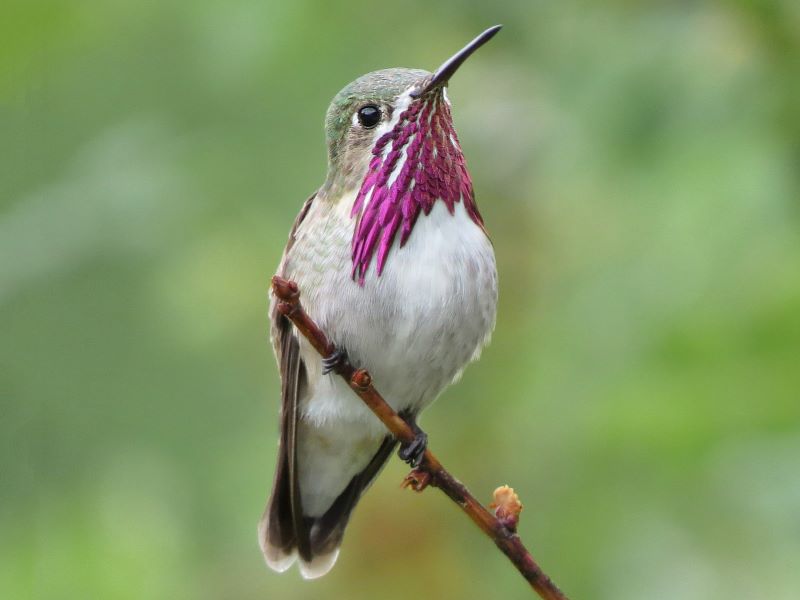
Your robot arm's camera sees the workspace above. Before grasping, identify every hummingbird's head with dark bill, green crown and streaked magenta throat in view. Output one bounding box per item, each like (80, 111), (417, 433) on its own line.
(323, 25), (500, 283)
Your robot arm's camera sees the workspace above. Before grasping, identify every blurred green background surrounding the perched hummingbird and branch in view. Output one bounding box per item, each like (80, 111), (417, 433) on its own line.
(0, 0), (800, 600)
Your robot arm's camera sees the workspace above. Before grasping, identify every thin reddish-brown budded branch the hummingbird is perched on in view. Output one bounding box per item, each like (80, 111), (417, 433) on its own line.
(272, 275), (567, 600)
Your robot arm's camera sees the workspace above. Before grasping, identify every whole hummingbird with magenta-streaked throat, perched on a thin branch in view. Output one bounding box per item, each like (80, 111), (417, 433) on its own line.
(258, 25), (500, 579)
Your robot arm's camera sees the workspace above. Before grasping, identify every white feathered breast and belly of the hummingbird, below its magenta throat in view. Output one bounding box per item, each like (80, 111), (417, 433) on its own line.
(283, 193), (497, 514)
